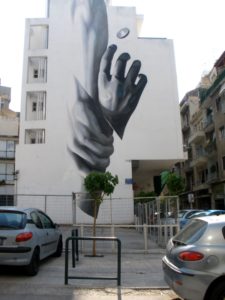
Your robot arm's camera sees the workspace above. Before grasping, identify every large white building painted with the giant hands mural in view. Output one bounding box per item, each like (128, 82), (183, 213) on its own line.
(16, 0), (183, 223)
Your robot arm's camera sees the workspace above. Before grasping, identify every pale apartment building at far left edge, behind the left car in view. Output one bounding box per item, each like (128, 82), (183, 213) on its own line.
(0, 82), (19, 206)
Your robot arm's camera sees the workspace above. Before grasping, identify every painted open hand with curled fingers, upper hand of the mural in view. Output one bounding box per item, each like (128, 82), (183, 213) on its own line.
(98, 45), (147, 138)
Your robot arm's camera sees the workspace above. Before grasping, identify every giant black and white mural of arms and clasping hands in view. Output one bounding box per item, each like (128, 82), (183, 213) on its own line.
(68, 0), (147, 214)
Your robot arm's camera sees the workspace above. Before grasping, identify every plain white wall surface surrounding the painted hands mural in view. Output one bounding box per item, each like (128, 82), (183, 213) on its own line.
(16, 0), (183, 223)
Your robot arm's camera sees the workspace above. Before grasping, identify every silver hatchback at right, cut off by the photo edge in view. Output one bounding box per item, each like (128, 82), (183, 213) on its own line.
(162, 215), (225, 300)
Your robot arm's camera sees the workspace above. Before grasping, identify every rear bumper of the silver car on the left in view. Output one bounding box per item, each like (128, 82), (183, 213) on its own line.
(0, 247), (32, 266)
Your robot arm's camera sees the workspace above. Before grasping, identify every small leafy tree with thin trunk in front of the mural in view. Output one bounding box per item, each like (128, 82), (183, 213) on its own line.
(84, 172), (119, 256)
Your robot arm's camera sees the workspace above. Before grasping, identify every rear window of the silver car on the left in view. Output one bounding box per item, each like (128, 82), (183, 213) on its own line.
(0, 210), (26, 230)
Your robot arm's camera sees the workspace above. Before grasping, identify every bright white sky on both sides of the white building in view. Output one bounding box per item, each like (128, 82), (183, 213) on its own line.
(0, 0), (225, 111)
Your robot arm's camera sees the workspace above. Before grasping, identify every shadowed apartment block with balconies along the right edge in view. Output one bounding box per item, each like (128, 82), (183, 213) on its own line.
(181, 53), (225, 209)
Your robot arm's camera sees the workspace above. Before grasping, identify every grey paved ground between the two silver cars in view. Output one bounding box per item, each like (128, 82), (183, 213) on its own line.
(0, 226), (180, 300)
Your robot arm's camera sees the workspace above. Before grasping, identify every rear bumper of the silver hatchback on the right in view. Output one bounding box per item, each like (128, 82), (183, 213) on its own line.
(162, 256), (216, 300)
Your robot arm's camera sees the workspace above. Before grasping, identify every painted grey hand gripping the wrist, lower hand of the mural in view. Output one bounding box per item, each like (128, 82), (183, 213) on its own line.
(68, 79), (114, 174)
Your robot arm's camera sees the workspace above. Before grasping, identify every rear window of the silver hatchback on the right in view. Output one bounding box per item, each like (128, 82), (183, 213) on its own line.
(173, 219), (208, 245)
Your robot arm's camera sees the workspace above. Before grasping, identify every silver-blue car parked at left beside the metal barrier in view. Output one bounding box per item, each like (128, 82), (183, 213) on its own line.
(0, 207), (63, 276)
